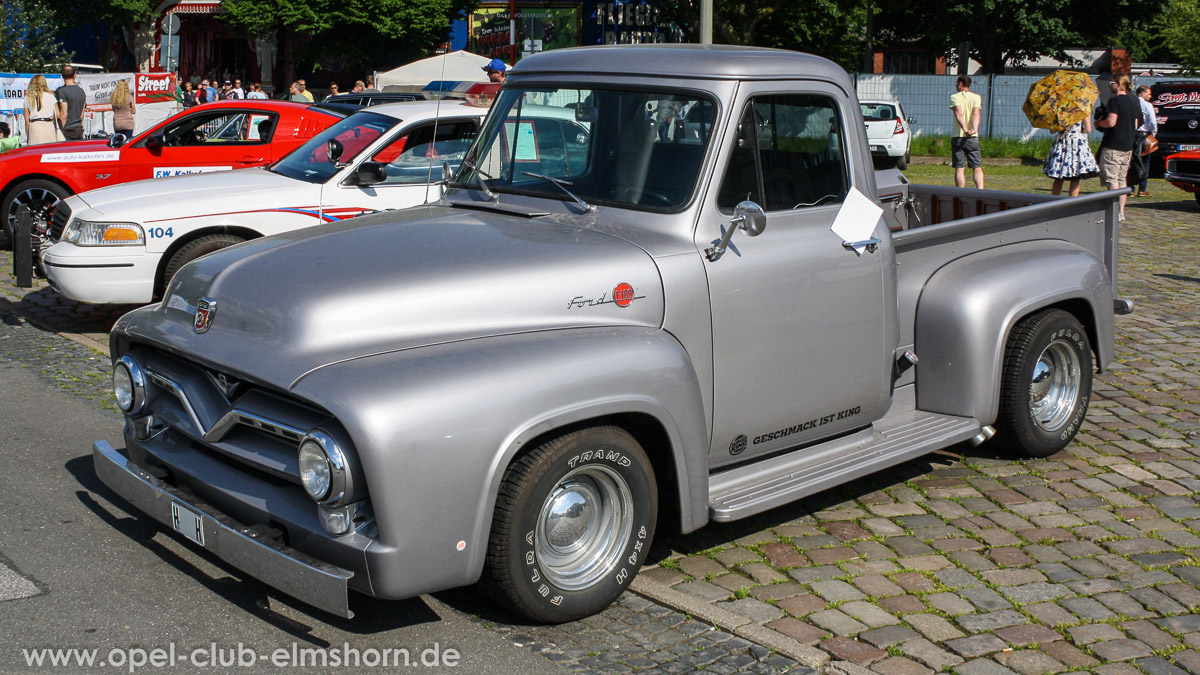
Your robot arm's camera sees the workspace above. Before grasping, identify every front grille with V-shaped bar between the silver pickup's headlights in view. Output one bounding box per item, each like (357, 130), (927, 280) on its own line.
(132, 350), (331, 483)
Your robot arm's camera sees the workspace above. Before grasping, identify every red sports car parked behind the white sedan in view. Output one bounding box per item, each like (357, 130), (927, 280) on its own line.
(0, 100), (343, 241)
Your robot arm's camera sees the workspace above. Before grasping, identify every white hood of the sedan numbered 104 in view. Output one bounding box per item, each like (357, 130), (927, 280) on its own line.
(79, 168), (304, 222)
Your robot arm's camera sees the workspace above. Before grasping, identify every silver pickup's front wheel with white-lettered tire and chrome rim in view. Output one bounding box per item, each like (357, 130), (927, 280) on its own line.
(481, 426), (658, 623)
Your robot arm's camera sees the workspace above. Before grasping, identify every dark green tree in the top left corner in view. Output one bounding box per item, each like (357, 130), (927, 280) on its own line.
(0, 0), (72, 73)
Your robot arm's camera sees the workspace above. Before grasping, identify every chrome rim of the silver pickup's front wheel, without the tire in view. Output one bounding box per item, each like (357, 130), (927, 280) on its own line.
(534, 465), (634, 591)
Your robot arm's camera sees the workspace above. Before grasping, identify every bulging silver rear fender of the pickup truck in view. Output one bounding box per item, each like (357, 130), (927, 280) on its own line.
(914, 240), (1114, 424)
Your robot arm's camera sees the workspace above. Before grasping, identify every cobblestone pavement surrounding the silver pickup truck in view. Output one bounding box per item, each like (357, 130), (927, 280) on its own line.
(0, 166), (1200, 675)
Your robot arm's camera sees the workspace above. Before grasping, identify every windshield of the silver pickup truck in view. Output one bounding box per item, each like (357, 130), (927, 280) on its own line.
(454, 88), (716, 211)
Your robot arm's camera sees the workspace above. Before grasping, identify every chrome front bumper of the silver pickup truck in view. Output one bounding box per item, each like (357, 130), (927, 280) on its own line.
(91, 441), (354, 619)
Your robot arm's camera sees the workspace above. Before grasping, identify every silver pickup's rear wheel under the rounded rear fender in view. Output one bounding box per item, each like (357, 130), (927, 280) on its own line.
(996, 310), (1092, 458)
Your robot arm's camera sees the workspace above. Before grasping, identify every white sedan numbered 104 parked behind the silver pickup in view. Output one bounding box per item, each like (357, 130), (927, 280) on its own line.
(41, 100), (588, 303)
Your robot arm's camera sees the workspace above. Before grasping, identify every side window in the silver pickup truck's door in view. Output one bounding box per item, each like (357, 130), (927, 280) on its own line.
(716, 94), (850, 211)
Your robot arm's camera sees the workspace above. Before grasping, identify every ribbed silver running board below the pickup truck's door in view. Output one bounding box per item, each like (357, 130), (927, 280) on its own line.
(708, 411), (983, 522)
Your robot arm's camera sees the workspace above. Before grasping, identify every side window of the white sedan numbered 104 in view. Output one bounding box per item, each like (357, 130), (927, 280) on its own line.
(371, 120), (479, 185)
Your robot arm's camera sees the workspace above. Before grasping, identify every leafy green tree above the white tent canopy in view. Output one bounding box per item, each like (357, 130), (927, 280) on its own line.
(220, 0), (478, 71)
